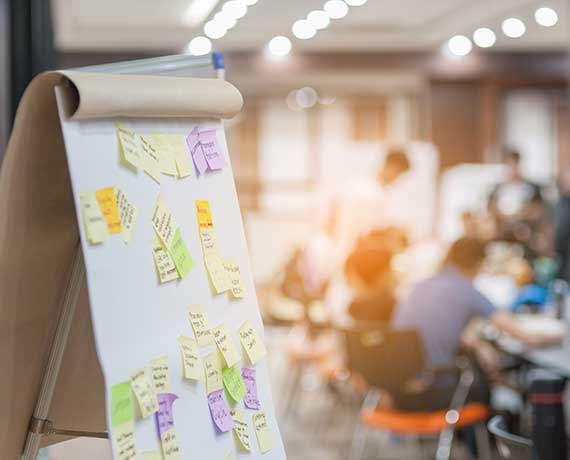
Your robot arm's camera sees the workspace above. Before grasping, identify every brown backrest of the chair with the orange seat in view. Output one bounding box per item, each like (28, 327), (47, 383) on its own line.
(345, 323), (424, 391)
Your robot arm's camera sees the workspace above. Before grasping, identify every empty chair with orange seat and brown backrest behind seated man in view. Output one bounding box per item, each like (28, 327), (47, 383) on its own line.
(345, 325), (491, 460)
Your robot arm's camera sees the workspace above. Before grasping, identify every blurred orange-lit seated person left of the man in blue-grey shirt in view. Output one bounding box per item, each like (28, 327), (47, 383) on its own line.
(344, 244), (396, 323)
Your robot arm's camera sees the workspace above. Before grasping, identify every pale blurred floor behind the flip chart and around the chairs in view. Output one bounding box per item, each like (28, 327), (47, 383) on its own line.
(40, 329), (469, 460)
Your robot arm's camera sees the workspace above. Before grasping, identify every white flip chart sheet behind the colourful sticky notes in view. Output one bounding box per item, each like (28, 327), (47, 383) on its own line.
(54, 88), (286, 460)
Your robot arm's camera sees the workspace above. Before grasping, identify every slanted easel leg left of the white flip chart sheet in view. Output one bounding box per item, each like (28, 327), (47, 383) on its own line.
(22, 246), (85, 460)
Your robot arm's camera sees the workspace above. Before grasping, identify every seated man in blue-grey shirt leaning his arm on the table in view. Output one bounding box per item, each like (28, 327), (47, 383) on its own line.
(392, 238), (561, 411)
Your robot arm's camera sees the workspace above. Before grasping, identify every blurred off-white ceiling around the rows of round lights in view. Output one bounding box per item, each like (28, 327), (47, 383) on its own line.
(52, 0), (570, 53)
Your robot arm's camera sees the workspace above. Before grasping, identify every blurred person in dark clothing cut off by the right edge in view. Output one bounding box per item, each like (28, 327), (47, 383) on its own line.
(554, 170), (570, 282)
